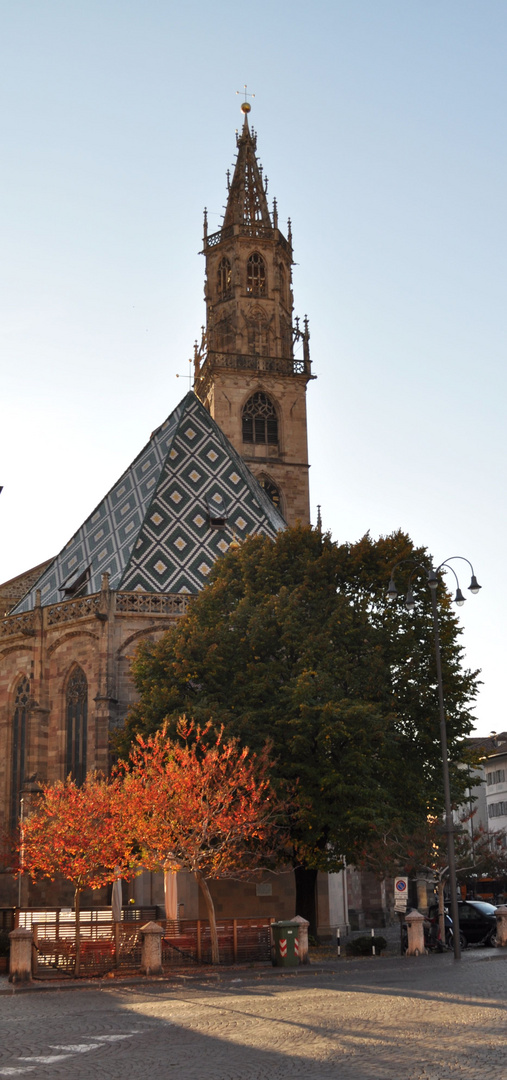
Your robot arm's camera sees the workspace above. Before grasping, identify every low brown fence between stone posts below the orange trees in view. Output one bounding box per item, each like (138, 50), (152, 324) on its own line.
(16, 907), (273, 977)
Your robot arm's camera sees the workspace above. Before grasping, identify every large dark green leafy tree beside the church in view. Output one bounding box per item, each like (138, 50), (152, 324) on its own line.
(119, 527), (477, 923)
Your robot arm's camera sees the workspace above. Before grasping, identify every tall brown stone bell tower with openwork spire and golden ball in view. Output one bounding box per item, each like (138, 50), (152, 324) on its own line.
(195, 102), (313, 525)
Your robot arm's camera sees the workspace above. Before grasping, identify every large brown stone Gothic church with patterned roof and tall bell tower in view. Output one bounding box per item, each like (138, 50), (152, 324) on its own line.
(0, 102), (381, 929)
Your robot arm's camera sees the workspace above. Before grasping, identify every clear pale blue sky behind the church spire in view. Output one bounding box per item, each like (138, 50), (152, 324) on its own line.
(0, 0), (507, 734)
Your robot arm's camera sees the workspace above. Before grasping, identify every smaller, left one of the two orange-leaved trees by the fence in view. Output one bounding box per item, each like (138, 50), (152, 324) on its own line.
(19, 773), (135, 975)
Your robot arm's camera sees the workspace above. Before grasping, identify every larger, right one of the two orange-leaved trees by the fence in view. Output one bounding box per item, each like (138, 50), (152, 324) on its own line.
(120, 717), (286, 963)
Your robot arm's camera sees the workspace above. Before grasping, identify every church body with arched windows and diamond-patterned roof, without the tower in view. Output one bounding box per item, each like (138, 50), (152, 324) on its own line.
(0, 392), (285, 906)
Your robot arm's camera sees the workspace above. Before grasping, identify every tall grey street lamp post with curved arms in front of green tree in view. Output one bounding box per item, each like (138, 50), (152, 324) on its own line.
(387, 555), (481, 960)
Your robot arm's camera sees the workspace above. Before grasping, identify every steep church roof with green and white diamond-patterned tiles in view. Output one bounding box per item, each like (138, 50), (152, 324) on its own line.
(14, 391), (285, 613)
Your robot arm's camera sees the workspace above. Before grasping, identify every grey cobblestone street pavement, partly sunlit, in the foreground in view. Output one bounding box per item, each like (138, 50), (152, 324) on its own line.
(0, 949), (507, 1080)
